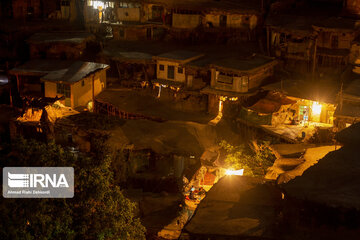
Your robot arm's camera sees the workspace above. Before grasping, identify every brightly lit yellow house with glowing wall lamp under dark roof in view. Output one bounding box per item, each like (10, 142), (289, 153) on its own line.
(262, 79), (340, 126)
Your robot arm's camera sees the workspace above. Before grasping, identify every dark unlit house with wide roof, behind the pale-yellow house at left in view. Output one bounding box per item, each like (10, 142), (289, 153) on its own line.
(27, 32), (95, 60)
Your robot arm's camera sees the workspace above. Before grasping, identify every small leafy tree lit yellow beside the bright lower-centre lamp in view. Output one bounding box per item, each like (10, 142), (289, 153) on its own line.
(220, 141), (276, 176)
